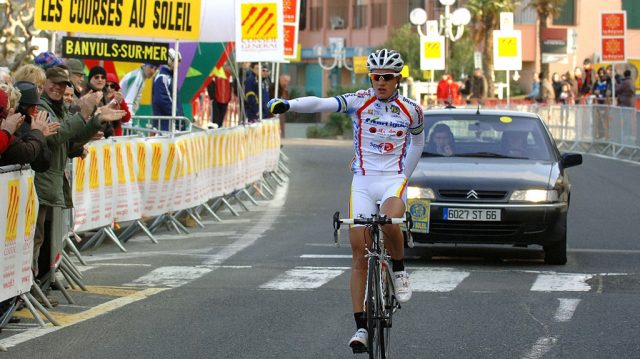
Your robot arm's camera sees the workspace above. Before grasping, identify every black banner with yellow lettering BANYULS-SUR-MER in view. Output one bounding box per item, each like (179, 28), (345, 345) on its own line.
(62, 36), (169, 64)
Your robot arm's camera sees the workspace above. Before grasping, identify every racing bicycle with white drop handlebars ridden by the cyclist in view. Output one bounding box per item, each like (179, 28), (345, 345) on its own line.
(333, 212), (413, 359)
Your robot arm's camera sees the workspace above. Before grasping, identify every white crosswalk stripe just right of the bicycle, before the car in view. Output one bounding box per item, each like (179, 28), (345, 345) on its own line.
(409, 268), (470, 292)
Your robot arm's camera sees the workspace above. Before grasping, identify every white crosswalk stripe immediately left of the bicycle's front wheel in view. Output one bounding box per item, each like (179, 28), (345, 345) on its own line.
(260, 267), (346, 290)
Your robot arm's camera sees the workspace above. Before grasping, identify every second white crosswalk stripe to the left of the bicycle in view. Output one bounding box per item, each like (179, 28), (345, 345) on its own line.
(124, 267), (212, 288)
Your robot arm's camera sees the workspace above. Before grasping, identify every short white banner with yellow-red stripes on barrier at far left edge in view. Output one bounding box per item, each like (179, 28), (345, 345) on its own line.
(0, 170), (38, 301)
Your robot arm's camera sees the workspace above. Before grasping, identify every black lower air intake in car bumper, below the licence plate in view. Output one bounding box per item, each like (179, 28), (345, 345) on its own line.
(429, 221), (520, 237)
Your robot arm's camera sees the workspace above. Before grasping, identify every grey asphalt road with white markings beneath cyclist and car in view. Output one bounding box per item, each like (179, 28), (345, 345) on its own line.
(0, 139), (640, 359)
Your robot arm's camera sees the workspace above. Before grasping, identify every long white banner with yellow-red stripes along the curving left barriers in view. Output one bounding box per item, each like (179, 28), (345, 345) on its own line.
(72, 120), (280, 232)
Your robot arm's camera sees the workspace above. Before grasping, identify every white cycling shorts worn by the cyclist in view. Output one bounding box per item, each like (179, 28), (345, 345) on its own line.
(349, 174), (407, 222)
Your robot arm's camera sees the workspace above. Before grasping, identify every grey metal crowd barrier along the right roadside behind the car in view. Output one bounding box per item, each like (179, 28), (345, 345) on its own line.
(472, 104), (640, 161)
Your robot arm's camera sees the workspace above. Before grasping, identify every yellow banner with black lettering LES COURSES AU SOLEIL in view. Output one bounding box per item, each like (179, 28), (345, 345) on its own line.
(34, 0), (201, 40)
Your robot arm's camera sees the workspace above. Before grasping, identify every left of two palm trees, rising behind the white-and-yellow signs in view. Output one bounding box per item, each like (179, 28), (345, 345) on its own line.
(466, 0), (517, 97)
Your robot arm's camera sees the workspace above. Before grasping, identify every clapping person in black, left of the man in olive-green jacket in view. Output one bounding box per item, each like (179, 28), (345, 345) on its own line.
(0, 81), (60, 172)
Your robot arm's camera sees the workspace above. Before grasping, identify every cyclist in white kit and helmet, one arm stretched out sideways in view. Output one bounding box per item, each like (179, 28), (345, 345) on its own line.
(268, 49), (424, 352)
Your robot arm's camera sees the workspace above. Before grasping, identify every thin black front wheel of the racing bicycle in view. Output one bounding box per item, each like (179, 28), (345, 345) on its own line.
(365, 257), (386, 359)
